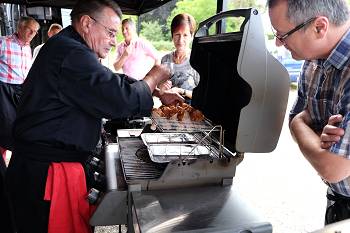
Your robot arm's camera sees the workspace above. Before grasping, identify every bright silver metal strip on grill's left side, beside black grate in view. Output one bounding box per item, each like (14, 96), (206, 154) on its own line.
(105, 143), (120, 190)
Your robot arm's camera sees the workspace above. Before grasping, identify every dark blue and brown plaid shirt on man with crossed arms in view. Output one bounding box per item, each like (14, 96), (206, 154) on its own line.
(289, 28), (350, 196)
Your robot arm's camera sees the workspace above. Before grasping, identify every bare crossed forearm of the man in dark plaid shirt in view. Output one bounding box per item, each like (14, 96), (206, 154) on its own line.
(290, 110), (350, 183)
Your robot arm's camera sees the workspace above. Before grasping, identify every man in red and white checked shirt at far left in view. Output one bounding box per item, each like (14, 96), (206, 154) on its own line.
(0, 17), (40, 159)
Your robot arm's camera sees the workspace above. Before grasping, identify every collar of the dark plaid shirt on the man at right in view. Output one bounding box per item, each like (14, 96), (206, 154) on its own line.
(317, 30), (350, 70)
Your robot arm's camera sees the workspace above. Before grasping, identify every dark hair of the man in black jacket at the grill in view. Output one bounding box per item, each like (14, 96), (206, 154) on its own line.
(70, 0), (122, 23)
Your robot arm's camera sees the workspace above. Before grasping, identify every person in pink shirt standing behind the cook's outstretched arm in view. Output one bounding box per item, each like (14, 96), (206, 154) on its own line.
(113, 18), (160, 80)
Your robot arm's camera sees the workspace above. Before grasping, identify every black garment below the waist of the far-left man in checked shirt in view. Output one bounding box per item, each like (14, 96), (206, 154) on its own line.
(0, 81), (22, 150)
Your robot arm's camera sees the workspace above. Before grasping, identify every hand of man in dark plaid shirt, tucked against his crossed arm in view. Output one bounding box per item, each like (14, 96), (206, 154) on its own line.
(320, 114), (344, 149)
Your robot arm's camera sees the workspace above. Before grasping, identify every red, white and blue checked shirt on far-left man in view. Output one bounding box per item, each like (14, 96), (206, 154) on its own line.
(0, 34), (32, 84)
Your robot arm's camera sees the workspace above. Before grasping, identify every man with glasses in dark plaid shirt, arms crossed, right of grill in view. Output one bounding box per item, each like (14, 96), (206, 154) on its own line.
(267, 0), (350, 224)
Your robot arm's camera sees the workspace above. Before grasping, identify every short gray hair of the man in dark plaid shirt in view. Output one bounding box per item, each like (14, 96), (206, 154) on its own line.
(267, 0), (349, 26)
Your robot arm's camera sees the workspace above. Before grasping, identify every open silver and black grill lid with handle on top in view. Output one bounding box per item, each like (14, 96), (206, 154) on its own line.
(190, 9), (289, 153)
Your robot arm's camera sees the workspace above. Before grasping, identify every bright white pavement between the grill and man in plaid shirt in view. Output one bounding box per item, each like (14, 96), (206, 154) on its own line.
(95, 88), (326, 233)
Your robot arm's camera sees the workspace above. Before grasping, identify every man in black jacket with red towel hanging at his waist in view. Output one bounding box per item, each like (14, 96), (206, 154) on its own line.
(6, 0), (182, 233)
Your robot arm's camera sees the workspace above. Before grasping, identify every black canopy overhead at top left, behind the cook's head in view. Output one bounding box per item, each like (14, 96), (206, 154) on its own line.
(1, 0), (171, 15)
